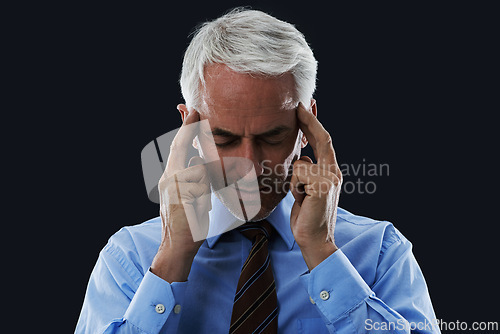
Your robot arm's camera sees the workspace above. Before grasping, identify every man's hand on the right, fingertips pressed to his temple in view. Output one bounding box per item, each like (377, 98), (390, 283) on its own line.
(290, 104), (342, 270)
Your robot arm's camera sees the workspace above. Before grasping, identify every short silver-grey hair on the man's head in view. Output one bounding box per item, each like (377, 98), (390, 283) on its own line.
(180, 8), (318, 110)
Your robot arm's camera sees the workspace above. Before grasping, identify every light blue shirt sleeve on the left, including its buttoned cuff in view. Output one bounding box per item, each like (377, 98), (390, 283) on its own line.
(75, 239), (187, 334)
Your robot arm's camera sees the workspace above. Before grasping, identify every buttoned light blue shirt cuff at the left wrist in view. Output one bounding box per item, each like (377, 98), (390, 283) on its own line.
(123, 270), (187, 333)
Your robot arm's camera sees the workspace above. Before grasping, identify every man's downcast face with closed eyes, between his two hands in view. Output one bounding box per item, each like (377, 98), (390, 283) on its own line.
(198, 65), (302, 221)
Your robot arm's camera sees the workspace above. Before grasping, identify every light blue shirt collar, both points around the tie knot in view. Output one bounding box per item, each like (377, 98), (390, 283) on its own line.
(207, 192), (295, 250)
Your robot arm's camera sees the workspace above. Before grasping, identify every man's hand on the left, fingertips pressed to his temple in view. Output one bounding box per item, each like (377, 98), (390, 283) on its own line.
(151, 110), (211, 282)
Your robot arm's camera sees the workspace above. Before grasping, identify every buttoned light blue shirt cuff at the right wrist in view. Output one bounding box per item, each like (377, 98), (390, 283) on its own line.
(300, 249), (372, 323)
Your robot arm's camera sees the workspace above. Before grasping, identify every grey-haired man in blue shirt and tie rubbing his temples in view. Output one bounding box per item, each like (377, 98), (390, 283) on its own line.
(76, 9), (439, 333)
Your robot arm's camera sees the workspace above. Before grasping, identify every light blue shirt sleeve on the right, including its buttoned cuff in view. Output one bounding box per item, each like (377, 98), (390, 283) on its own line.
(301, 234), (440, 333)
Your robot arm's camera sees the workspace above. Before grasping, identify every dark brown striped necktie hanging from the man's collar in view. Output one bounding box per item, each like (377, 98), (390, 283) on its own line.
(229, 220), (278, 334)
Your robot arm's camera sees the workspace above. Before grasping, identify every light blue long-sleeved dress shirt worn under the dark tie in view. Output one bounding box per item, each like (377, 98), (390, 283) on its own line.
(76, 193), (440, 334)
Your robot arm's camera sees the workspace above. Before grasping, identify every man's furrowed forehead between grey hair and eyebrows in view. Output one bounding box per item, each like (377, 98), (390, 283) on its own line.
(199, 64), (298, 119)
